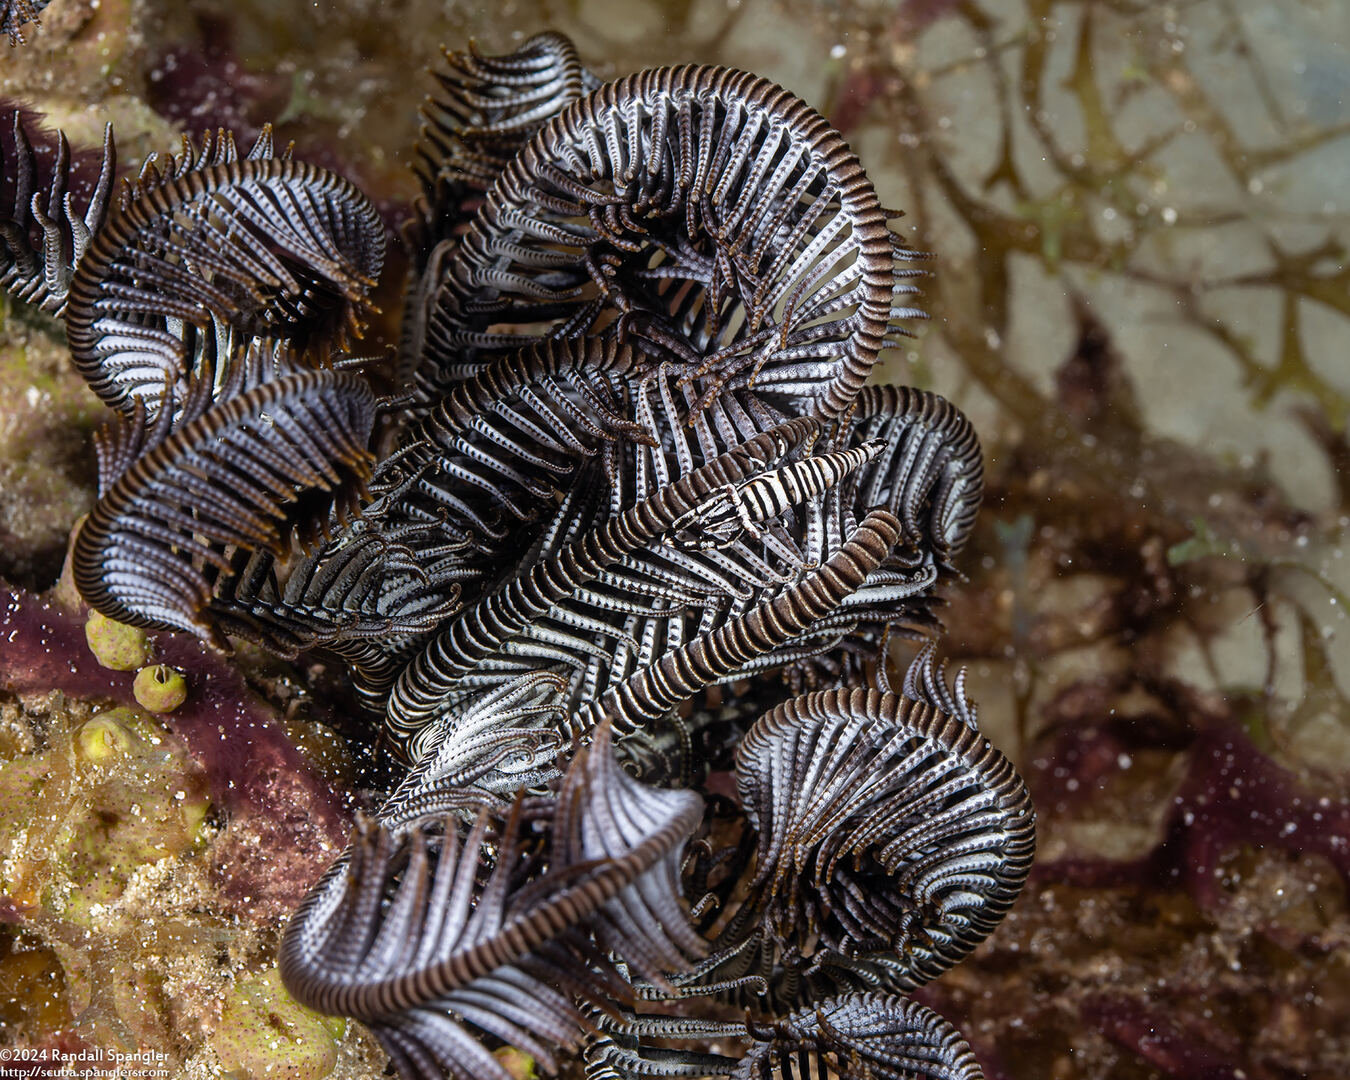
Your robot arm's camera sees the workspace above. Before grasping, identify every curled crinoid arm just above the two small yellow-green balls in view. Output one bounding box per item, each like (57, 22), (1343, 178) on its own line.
(73, 371), (375, 643)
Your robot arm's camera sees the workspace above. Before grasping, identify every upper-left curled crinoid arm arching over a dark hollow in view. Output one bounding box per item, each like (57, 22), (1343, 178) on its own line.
(66, 131), (385, 412)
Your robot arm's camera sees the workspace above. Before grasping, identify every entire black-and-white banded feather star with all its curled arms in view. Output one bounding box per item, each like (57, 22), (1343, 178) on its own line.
(0, 34), (1034, 1080)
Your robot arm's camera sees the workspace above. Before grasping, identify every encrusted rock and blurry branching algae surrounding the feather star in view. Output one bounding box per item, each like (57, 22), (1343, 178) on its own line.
(0, 0), (1350, 1080)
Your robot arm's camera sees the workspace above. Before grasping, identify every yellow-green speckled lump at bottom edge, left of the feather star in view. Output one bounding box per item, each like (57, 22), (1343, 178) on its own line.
(211, 968), (347, 1080)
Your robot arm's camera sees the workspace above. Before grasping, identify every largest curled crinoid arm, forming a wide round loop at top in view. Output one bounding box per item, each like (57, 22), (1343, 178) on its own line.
(413, 66), (917, 416)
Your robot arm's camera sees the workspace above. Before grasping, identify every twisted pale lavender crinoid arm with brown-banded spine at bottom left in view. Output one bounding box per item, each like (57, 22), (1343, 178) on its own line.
(281, 733), (702, 1080)
